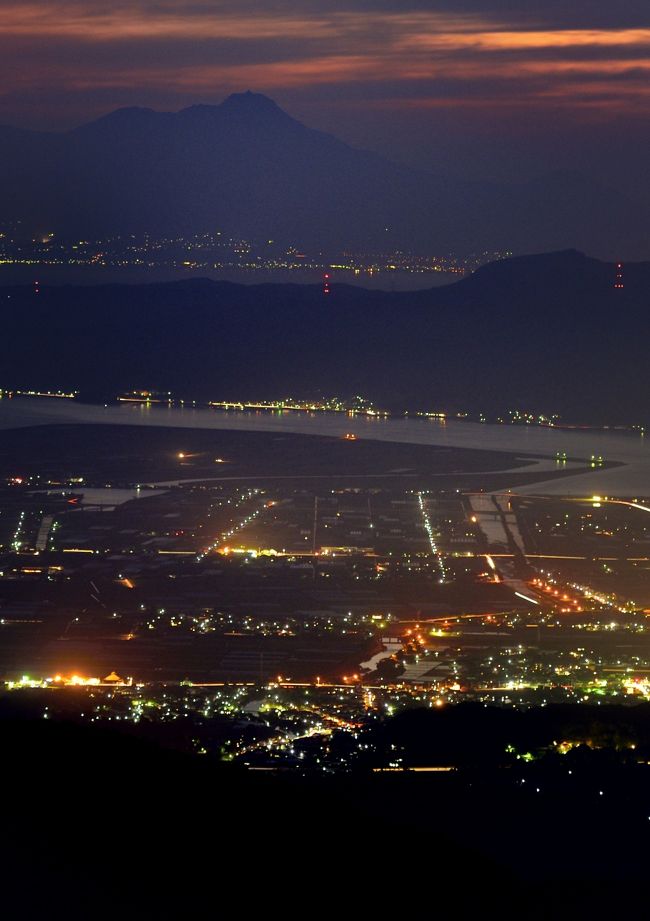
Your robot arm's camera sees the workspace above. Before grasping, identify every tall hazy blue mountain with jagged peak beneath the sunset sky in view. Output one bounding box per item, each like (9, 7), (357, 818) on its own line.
(0, 92), (650, 258)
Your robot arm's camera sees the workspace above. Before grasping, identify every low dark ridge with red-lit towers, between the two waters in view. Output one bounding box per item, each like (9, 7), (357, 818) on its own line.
(0, 251), (650, 424)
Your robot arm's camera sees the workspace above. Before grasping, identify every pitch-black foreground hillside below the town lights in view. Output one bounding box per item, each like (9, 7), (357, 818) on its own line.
(1, 707), (647, 919)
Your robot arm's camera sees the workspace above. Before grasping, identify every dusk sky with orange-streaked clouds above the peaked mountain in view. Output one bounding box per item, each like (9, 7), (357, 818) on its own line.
(0, 0), (650, 195)
